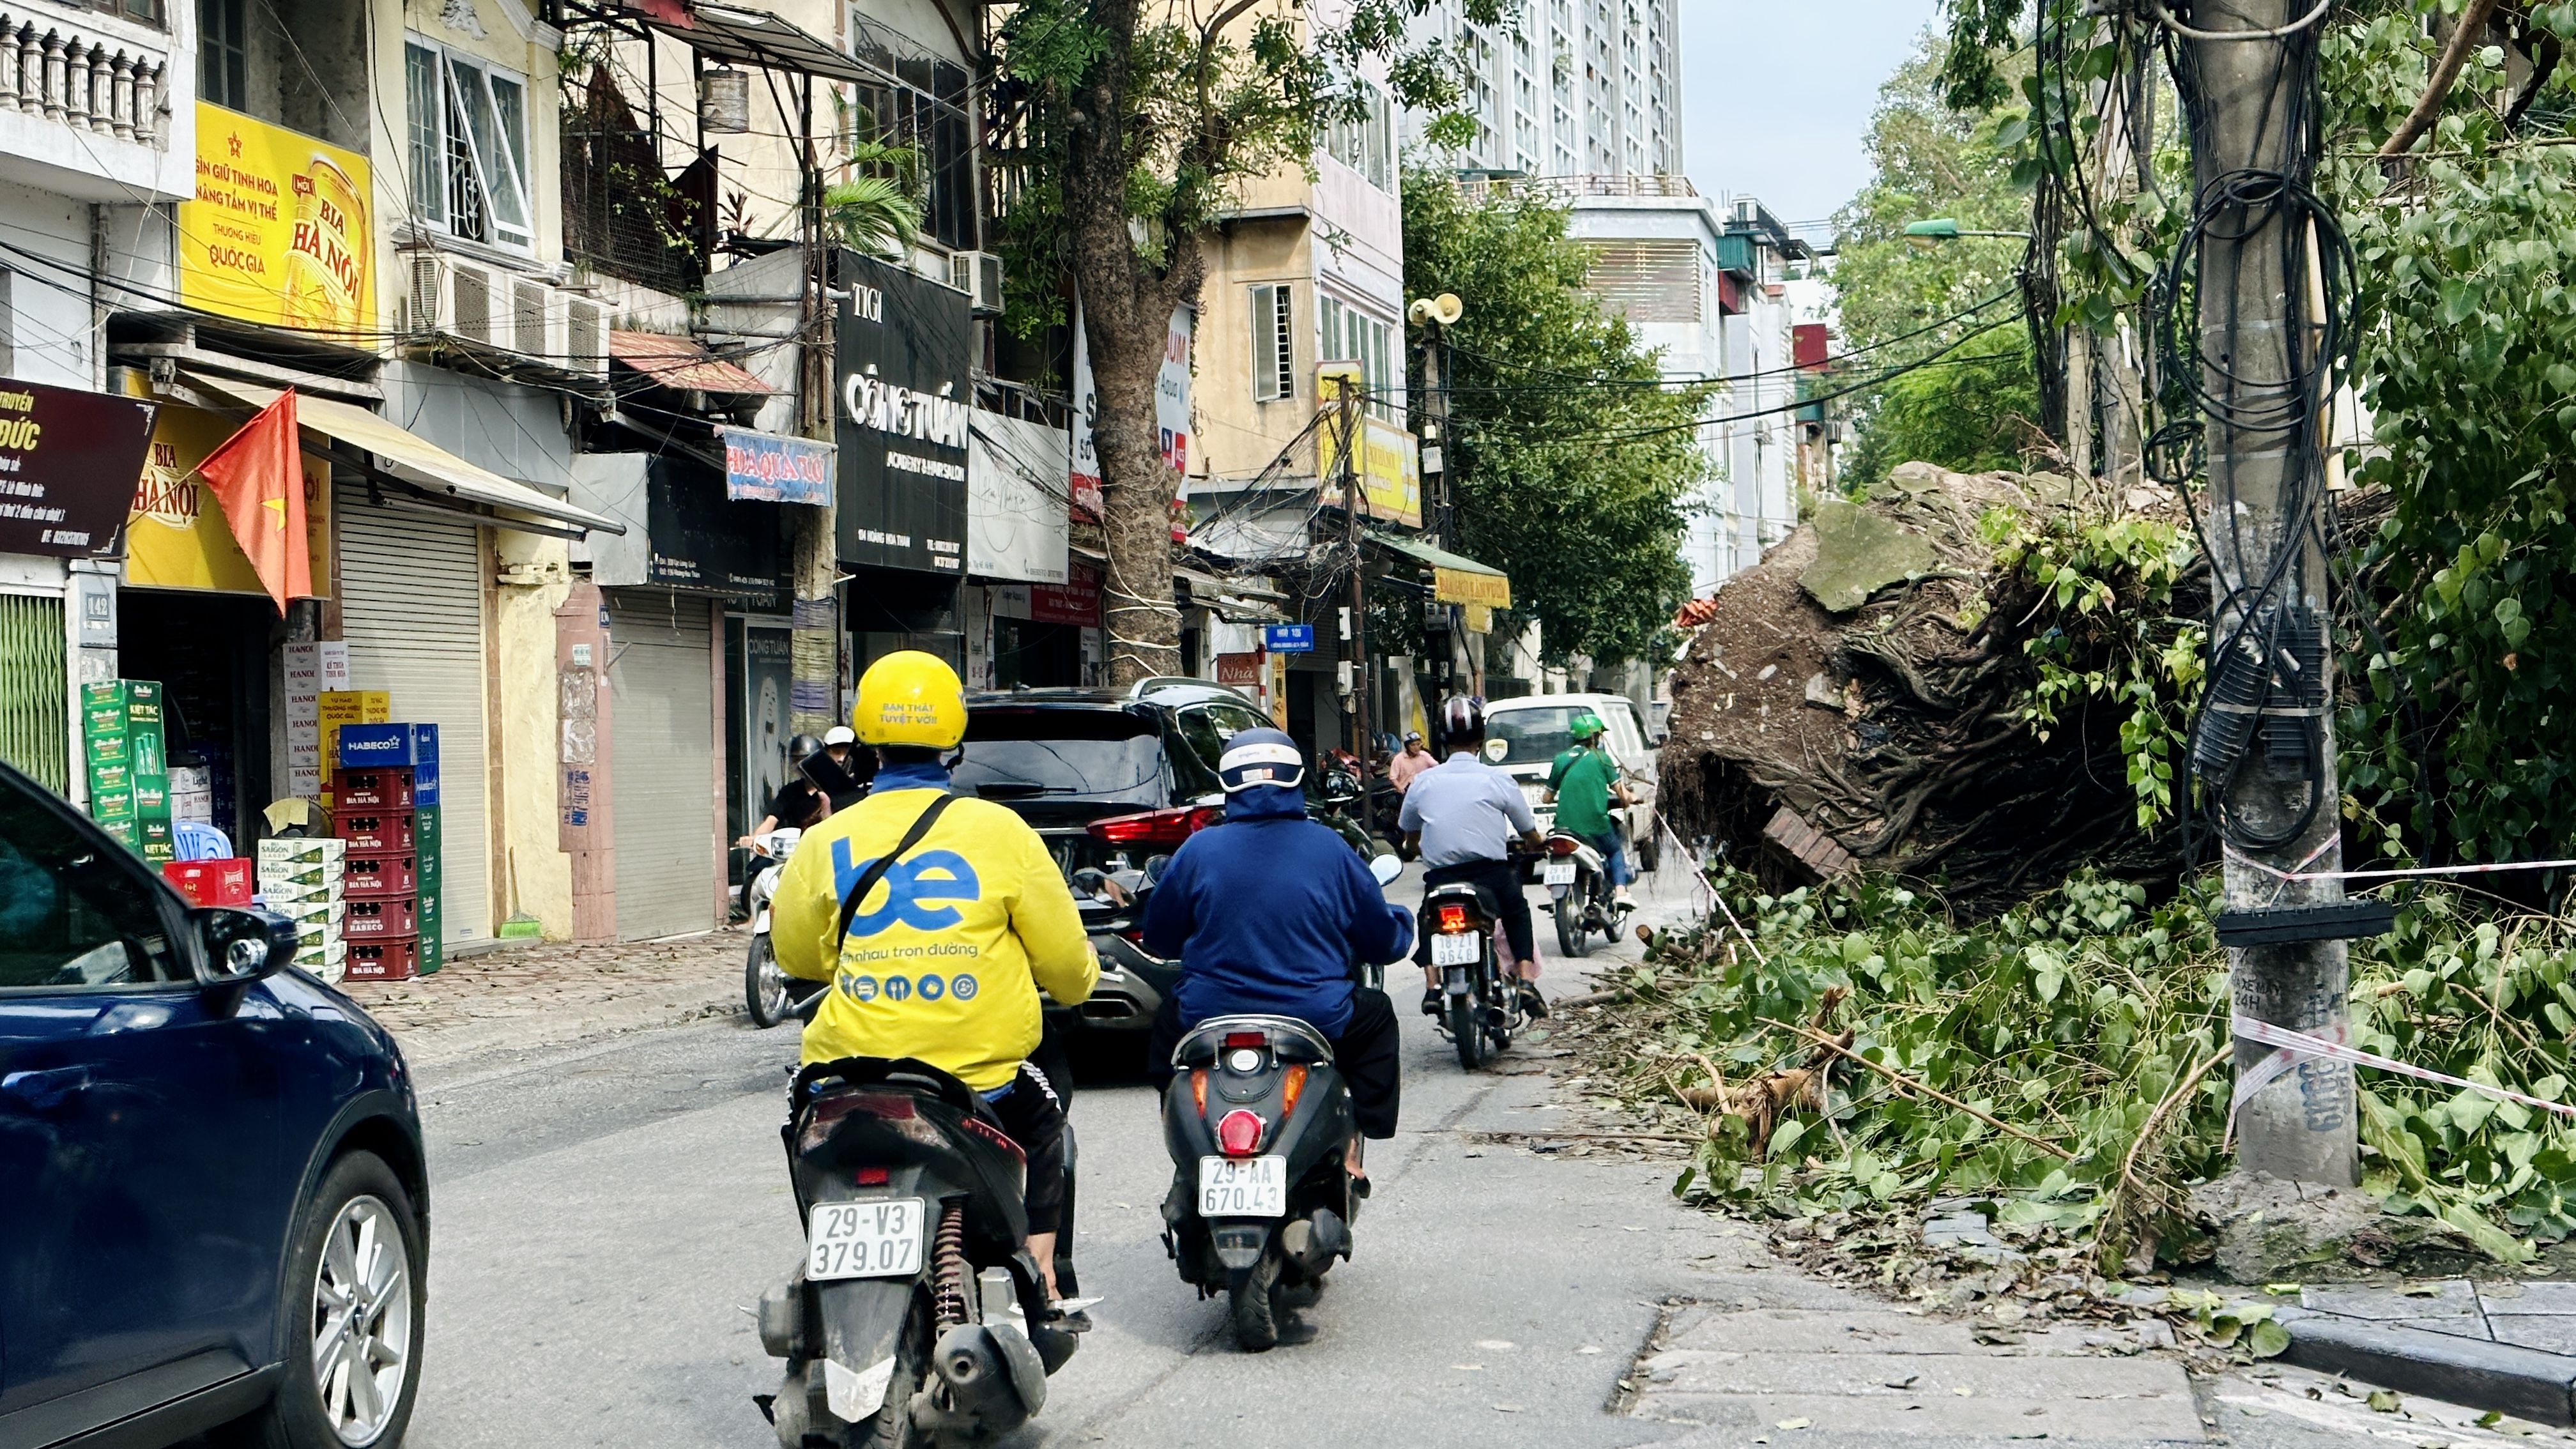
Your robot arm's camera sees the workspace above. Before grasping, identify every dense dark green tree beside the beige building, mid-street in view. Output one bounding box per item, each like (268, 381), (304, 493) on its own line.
(1404, 170), (1710, 663)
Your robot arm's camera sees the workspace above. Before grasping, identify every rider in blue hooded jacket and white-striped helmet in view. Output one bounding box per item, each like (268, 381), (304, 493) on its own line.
(1144, 730), (1414, 1165)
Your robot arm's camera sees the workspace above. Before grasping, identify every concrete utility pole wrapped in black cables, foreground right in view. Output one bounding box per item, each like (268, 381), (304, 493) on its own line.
(2177, 0), (2359, 1186)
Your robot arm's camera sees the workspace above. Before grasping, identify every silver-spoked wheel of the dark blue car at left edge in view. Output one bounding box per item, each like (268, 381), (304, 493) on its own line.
(237, 1153), (425, 1449)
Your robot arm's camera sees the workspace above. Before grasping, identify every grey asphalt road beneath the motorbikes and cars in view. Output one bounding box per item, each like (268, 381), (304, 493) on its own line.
(386, 855), (2452, 1449)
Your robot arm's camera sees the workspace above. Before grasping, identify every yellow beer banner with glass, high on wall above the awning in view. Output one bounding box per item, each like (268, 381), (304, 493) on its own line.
(178, 100), (376, 333)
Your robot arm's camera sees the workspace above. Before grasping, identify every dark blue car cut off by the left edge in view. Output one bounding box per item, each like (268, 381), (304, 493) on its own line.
(0, 766), (430, 1449)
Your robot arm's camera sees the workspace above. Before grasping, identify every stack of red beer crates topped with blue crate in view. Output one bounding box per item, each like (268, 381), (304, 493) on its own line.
(332, 724), (443, 980)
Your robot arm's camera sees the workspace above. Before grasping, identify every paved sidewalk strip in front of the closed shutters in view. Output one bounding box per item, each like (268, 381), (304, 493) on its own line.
(340, 926), (749, 1068)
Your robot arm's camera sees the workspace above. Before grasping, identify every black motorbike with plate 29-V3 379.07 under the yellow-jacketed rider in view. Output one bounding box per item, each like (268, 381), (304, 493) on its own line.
(755, 1057), (1090, 1449)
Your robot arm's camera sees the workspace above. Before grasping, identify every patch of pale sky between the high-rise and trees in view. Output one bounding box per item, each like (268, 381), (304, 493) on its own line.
(1680, 0), (1940, 234)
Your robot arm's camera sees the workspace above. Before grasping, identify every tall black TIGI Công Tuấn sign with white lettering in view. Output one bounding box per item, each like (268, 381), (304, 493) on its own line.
(834, 258), (974, 575)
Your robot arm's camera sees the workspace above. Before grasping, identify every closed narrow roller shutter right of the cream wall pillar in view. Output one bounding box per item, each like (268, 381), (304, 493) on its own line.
(608, 590), (716, 941)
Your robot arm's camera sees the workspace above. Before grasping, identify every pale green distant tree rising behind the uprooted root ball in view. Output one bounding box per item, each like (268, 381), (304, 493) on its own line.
(1834, 33), (2040, 485)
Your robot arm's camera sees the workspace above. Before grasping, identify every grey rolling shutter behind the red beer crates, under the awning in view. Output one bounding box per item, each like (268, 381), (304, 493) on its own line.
(332, 487), (492, 944)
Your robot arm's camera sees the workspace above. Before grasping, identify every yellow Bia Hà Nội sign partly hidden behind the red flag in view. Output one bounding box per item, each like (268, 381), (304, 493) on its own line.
(126, 405), (330, 595)
